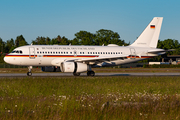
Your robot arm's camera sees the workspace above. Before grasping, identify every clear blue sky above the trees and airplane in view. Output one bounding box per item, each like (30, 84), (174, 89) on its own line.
(0, 0), (180, 44)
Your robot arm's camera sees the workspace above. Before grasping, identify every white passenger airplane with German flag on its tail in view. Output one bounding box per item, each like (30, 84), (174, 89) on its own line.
(4, 17), (166, 76)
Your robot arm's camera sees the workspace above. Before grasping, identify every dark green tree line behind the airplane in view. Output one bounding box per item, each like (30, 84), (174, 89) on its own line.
(0, 29), (180, 62)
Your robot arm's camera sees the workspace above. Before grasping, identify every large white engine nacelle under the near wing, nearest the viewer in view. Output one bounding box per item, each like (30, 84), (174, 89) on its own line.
(61, 62), (88, 73)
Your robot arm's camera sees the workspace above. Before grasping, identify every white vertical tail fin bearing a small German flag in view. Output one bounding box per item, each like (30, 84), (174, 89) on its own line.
(130, 17), (163, 48)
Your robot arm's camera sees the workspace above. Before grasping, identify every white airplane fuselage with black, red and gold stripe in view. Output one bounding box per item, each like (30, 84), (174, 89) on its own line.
(4, 45), (162, 66)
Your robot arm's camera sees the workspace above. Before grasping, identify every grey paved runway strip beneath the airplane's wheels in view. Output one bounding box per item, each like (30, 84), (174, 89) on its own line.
(0, 72), (180, 77)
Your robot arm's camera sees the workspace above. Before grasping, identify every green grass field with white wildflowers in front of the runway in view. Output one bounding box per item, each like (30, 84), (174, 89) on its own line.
(0, 76), (180, 120)
